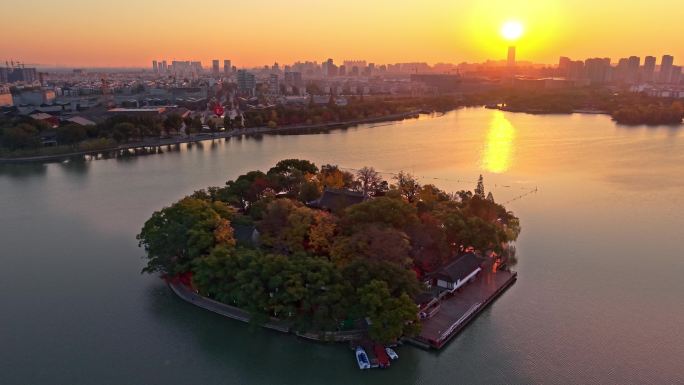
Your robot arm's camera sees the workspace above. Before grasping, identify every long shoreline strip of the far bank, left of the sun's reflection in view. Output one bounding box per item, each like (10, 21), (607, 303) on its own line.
(0, 110), (424, 164)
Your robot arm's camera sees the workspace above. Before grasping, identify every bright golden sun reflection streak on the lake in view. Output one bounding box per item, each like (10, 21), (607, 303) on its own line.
(482, 111), (515, 174)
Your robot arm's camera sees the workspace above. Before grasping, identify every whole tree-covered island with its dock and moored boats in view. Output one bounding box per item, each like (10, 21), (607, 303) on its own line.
(138, 159), (520, 354)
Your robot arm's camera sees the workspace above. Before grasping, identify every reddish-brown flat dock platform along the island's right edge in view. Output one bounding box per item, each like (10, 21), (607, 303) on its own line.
(406, 265), (518, 349)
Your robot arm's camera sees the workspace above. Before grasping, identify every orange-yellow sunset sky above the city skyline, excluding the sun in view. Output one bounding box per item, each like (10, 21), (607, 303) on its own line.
(0, 0), (684, 66)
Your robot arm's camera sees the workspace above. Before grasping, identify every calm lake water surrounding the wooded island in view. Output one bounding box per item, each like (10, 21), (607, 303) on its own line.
(0, 109), (684, 385)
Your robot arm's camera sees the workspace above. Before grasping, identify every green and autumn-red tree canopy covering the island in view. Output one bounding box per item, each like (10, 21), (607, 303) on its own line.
(138, 159), (520, 342)
